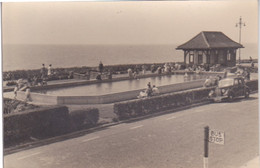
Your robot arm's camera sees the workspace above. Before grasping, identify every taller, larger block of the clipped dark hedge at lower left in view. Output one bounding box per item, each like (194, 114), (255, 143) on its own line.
(4, 106), (70, 145)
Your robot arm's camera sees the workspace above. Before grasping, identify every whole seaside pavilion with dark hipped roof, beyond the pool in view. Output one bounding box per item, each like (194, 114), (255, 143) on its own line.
(176, 31), (244, 67)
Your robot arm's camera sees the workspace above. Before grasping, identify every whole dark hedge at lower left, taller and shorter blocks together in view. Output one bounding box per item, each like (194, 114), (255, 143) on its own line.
(4, 106), (99, 147)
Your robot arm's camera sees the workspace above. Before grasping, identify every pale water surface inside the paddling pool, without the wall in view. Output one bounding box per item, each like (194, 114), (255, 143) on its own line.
(39, 74), (208, 96)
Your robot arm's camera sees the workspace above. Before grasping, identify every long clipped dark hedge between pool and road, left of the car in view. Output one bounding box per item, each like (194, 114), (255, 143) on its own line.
(114, 88), (212, 120)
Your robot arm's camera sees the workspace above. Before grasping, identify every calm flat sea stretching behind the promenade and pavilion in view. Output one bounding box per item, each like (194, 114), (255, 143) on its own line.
(2, 43), (258, 72)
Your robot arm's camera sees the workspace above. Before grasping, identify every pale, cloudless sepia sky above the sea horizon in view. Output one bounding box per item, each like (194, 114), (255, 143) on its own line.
(2, 0), (258, 45)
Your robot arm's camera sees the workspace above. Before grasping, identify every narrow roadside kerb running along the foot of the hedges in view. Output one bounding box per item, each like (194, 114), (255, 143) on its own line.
(3, 100), (210, 156)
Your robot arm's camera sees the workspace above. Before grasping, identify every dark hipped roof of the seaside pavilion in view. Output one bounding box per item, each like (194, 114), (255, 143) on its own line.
(176, 31), (244, 50)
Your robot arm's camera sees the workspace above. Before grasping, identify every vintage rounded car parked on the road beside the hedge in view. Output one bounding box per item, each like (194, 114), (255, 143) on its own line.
(209, 77), (250, 102)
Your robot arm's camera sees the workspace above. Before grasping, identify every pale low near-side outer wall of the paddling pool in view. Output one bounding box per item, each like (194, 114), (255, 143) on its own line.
(17, 79), (205, 104)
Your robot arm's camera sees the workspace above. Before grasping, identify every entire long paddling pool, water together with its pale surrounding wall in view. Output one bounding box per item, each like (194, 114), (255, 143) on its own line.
(17, 73), (228, 104)
